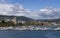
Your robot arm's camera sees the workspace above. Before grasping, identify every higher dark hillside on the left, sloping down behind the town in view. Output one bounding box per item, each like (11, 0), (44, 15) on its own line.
(0, 15), (34, 21)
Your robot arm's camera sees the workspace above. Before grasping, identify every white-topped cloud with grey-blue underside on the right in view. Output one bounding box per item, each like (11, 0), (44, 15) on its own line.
(38, 8), (60, 19)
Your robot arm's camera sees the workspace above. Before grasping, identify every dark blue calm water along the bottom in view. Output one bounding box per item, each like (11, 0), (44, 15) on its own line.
(0, 31), (60, 38)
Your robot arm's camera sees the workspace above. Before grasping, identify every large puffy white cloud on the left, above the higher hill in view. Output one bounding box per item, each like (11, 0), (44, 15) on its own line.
(0, 4), (25, 15)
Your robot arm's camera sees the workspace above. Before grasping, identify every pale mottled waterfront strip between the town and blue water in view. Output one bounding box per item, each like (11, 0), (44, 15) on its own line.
(0, 26), (60, 30)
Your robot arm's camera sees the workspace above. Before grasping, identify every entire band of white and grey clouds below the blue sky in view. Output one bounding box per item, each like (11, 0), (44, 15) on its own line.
(0, 4), (60, 19)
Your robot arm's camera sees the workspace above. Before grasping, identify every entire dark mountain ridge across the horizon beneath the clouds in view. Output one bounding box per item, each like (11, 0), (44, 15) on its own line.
(0, 15), (60, 22)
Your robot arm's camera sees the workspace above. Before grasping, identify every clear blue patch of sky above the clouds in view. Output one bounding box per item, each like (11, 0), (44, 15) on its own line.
(3, 0), (60, 10)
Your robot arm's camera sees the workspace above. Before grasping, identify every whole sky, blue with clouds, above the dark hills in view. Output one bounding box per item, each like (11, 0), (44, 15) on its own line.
(0, 0), (60, 19)
